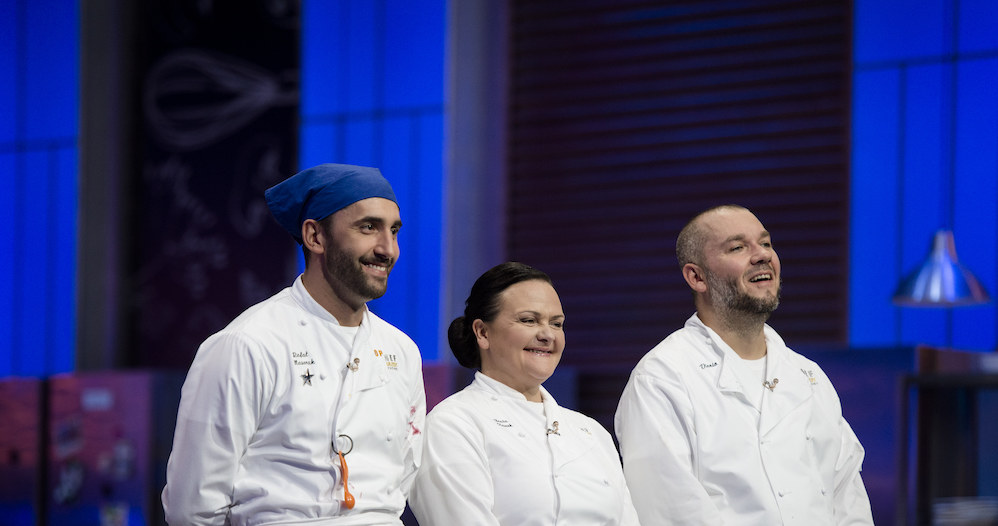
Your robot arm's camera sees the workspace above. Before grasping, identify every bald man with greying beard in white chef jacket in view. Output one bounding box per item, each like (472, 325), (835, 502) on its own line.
(614, 205), (873, 526)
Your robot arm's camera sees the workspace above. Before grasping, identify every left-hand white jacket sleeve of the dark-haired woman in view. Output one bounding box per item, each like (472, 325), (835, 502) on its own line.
(409, 411), (499, 526)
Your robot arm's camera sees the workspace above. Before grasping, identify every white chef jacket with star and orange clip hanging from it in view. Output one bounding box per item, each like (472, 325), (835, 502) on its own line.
(163, 276), (426, 526)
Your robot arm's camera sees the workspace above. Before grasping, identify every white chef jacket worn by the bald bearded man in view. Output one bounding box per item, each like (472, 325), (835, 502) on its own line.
(614, 314), (873, 526)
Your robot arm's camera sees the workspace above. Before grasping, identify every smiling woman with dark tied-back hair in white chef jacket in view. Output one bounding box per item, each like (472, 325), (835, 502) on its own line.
(409, 263), (638, 526)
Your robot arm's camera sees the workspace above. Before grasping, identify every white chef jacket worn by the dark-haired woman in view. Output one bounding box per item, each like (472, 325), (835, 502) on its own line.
(409, 372), (638, 526)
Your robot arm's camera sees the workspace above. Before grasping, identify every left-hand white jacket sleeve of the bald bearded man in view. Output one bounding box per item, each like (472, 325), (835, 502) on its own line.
(614, 371), (723, 526)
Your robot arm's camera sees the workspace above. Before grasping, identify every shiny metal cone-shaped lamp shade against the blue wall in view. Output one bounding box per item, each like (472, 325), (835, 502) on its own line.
(894, 230), (989, 307)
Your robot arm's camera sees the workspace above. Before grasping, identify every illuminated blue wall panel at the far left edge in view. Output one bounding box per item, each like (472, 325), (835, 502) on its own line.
(0, 0), (79, 377)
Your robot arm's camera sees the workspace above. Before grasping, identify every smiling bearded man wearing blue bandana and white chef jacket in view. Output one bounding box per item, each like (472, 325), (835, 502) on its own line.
(163, 164), (426, 526)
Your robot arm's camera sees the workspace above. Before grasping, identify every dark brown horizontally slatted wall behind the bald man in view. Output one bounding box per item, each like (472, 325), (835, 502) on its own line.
(508, 0), (851, 420)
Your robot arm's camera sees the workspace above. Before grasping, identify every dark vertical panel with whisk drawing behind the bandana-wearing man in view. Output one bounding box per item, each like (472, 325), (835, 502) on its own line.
(130, 0), (299, 368)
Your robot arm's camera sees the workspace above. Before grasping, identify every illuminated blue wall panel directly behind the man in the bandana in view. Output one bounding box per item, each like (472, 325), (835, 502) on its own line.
(299, 0), (447, 360)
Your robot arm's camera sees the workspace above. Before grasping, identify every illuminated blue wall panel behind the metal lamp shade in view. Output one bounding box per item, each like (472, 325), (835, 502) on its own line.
(849, 0), (998, 350)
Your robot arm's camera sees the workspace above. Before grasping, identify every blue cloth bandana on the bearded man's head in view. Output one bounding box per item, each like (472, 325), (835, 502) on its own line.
(264, 164), (398, 245)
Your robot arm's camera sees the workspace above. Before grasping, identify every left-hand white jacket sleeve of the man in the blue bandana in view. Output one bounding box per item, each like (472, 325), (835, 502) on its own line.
(162, 334), (274, 526)
